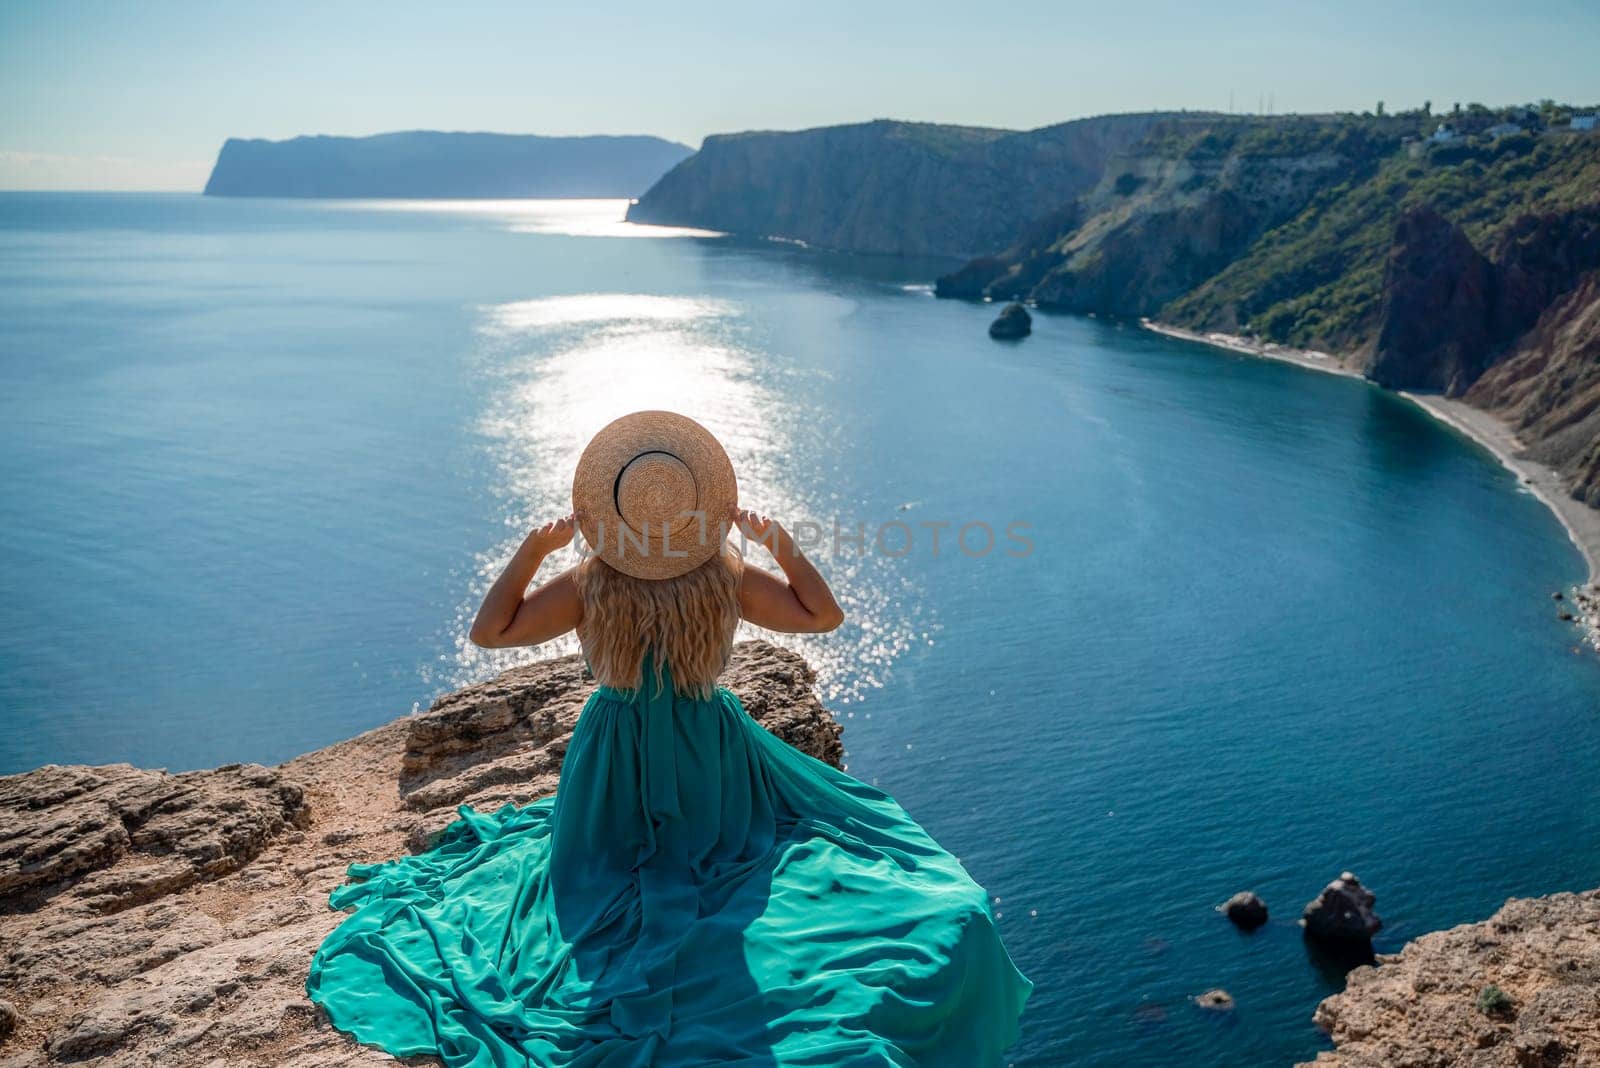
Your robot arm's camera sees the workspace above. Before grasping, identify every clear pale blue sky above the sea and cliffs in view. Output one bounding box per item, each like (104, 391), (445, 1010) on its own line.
(0, 0), (1600, 190)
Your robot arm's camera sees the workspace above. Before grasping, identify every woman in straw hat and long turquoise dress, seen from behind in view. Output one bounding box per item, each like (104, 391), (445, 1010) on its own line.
(307, 412), (1032, 1068)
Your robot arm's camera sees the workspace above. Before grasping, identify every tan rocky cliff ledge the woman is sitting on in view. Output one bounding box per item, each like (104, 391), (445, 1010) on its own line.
(0, 641), (843, 1068)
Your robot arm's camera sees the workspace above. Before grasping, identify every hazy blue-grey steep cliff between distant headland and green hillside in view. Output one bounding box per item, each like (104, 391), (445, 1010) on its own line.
(627, 114), (1163, 257)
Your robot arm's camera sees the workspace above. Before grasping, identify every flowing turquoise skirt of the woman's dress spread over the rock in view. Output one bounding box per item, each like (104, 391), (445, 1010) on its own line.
(306, 661), (1034, 1068)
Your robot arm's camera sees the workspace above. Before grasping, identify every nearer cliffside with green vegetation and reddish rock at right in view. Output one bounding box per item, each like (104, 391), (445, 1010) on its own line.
(936, 107), (1600, 507)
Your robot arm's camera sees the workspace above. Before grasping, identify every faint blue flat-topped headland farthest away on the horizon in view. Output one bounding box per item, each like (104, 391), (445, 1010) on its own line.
(205, 130), (693, 200)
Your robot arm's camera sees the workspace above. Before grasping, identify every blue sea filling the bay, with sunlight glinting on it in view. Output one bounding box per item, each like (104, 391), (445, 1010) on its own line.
(0, 195), (1600, 1065)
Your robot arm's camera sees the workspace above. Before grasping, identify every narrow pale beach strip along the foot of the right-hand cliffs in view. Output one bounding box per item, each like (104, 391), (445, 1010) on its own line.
(1139, 318), (1600, 597)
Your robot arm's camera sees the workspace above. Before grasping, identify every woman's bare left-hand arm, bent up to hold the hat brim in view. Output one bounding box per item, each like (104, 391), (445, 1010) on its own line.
(467, 515), (584, 649)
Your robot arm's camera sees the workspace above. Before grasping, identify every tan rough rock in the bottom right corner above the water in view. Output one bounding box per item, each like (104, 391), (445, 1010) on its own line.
(1314, 891), (1600, 1068)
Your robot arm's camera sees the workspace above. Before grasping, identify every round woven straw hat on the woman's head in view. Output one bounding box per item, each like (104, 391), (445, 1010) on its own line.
(573, 411), (739, 579)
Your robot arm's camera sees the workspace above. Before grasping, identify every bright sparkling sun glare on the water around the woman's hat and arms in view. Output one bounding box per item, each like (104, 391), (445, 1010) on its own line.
(441, 293), (920, 703)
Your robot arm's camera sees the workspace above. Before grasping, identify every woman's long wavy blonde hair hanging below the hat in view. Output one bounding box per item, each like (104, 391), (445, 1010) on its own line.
(576, 544), (744, 697)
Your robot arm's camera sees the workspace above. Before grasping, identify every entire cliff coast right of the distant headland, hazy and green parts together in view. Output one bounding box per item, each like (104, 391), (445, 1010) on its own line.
(629, 106), (1600, 518)
